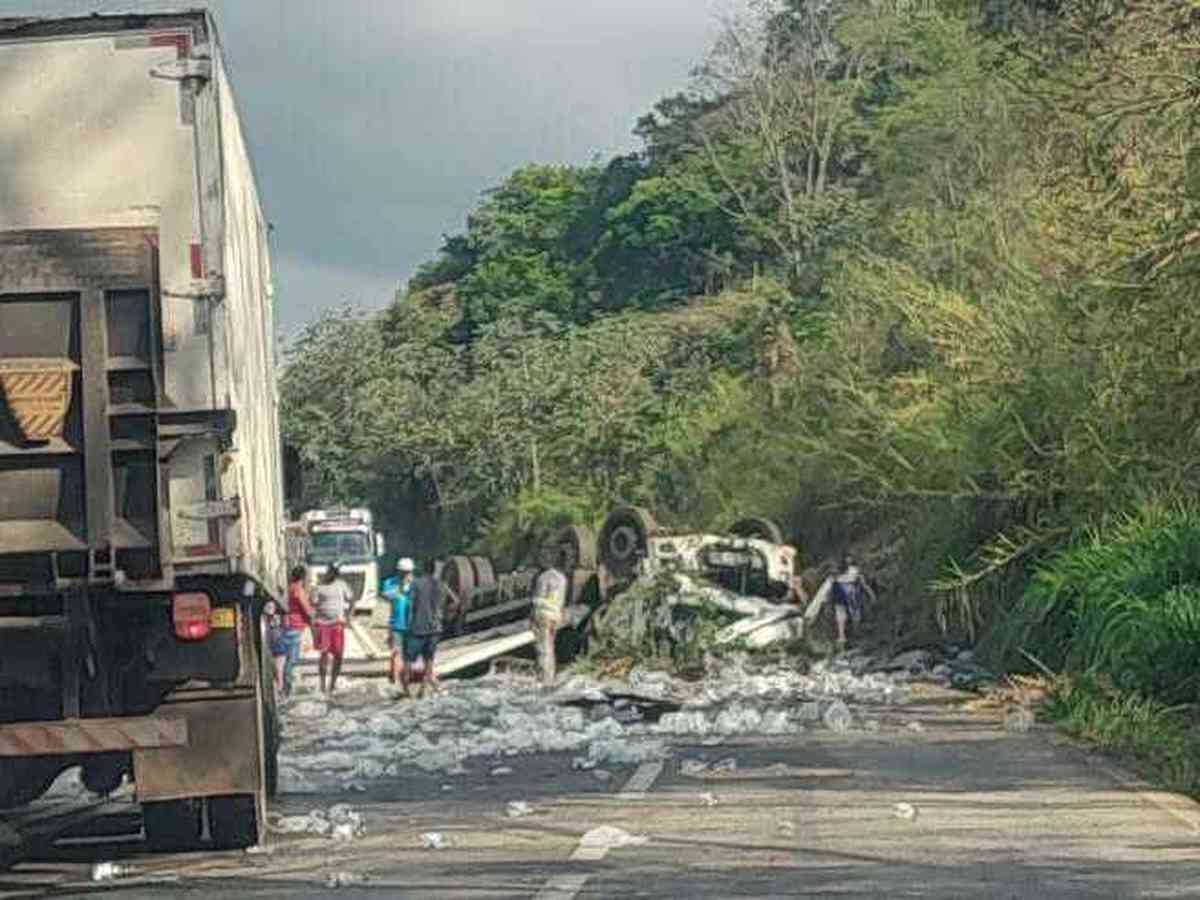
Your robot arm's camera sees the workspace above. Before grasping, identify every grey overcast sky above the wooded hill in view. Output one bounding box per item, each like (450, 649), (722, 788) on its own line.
(0, 0), (728, 335)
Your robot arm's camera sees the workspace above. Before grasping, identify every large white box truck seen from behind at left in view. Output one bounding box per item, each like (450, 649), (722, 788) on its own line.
(0, 12), (286, 850)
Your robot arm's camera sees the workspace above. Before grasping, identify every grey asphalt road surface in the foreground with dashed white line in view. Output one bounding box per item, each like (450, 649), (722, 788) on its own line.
(0, 695), (1200, 900)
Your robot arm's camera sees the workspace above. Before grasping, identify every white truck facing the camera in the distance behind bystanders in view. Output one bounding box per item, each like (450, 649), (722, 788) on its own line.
(300, 509), (384, 613)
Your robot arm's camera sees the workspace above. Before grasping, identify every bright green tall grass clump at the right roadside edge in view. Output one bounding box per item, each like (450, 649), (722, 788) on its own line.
(994, 503), (1200, 704)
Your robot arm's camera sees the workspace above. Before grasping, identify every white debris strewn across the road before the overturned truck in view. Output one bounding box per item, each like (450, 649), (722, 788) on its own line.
(280, 654), (910, 796)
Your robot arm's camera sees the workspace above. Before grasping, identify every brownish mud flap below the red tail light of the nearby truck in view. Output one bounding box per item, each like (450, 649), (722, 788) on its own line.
(133, 696), (263, 802)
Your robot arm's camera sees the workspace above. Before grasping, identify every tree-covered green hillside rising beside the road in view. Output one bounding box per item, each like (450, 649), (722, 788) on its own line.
(282, 0), (1200, 784)
